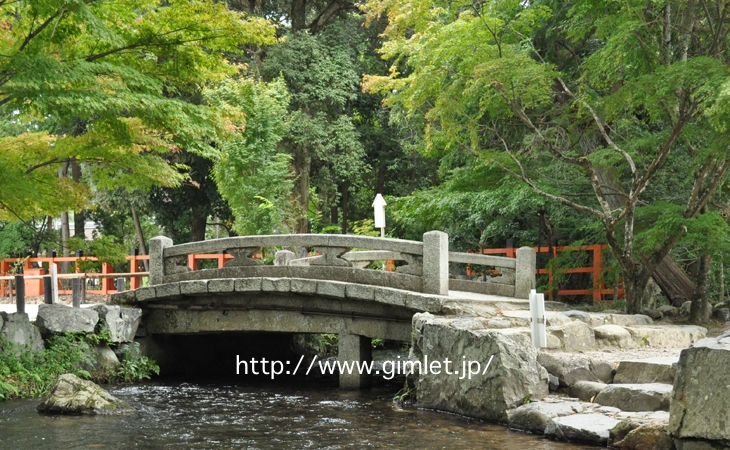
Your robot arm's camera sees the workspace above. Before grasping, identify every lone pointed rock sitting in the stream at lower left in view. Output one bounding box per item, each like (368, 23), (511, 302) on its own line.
(37, 373), (134, 415)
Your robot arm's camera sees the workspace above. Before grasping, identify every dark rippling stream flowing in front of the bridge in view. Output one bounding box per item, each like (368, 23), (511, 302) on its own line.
(0, 381), (594, 450)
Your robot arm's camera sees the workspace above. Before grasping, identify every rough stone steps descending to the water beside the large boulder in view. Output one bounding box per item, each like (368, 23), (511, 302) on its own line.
(509, 353), (679, 449)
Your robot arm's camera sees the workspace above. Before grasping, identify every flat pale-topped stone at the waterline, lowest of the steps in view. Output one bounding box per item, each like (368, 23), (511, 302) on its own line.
(545, 414), (619, 445)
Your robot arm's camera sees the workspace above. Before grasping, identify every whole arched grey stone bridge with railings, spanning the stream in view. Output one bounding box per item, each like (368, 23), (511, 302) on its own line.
(112, 231), (535, 387)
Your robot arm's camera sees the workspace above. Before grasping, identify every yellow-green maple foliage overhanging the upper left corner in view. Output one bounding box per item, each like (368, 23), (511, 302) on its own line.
(0, 0), (275, 218)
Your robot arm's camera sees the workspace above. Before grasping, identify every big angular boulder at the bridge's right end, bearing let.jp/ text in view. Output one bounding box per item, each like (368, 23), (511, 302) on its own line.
(413, 313), (548, 423)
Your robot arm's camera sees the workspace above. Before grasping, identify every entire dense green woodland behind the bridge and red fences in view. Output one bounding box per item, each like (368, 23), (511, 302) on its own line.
(0, 0), (730, 320)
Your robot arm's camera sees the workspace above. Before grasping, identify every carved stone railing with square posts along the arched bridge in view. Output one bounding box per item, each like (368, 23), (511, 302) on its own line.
(149, 231), (535, 299)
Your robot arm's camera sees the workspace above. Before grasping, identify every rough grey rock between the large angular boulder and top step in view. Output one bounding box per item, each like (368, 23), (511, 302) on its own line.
(537, 351), (612, 386)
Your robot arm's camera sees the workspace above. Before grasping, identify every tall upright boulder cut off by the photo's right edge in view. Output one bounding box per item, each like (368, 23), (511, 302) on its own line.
(669, 332), (730, 440)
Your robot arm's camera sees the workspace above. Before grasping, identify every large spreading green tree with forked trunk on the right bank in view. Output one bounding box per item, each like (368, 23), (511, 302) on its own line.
(365, 0), (730, 313)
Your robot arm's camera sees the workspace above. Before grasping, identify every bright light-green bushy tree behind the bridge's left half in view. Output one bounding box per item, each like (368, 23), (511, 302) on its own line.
(206, 78), (293, 235)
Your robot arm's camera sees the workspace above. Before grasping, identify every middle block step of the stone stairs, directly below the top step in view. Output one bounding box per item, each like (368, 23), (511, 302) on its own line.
(593, 383), (672, 411)
